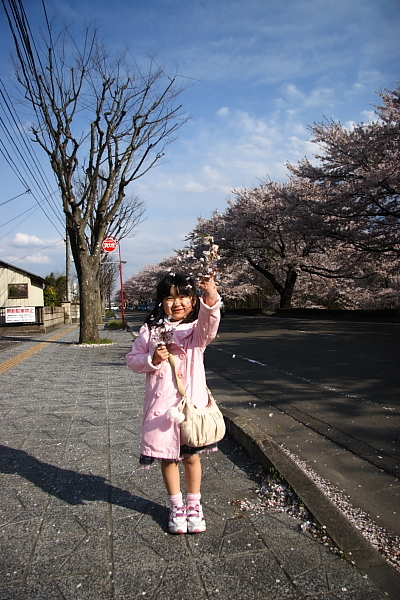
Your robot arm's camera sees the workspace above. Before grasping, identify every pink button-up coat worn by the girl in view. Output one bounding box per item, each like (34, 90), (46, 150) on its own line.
(126, 299), (220, 459)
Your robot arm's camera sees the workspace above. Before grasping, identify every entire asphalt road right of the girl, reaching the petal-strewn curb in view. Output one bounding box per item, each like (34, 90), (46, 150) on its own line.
(205, 315), (400, 536)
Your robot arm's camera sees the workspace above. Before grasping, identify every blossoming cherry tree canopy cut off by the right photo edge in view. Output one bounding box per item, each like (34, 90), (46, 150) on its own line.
(288, 87), (400, 272)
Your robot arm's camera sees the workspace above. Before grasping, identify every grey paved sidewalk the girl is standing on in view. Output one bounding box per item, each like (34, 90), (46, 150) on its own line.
(0, 327), (388, 600)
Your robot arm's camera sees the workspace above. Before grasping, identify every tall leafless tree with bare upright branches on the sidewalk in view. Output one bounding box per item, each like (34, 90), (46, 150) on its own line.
(2, 0), (187, 342)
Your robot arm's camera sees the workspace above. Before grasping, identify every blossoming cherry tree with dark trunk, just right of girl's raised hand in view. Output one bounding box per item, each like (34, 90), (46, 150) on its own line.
(188, 176), (390, 308)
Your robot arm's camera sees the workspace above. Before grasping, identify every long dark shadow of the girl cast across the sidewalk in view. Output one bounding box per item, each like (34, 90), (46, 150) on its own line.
(0, 444), (168, 531)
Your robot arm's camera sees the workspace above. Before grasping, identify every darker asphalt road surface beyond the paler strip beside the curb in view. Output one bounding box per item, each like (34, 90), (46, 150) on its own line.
(206, 315), (400, 475)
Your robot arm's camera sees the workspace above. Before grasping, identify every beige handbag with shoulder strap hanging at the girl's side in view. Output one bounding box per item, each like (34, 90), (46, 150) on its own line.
(168, 353), (225, 448)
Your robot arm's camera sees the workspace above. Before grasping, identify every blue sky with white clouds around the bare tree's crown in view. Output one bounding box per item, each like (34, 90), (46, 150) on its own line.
(0, 0), (400, 278)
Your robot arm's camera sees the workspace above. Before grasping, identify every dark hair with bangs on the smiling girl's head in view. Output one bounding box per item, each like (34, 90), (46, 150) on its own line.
(145, 274), (200, 327)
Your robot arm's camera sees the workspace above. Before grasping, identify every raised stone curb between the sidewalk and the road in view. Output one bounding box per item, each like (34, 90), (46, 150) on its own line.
(221, 407), (400, 600)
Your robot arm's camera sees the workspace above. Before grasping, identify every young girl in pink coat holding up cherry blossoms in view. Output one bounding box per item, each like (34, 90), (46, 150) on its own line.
(126, 274), (220, 533)
